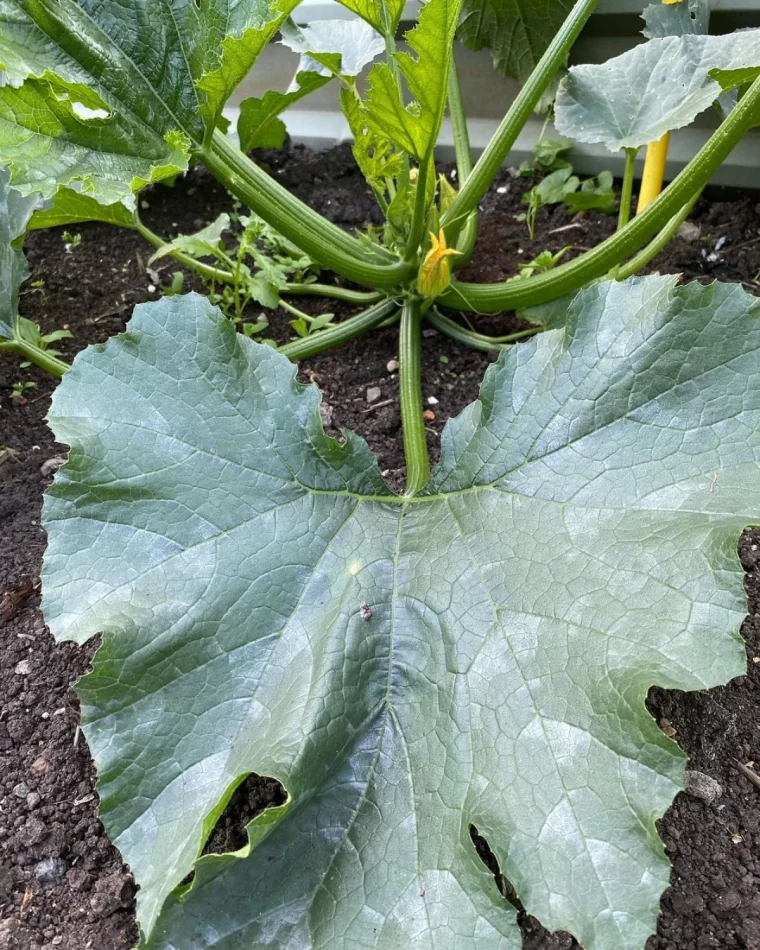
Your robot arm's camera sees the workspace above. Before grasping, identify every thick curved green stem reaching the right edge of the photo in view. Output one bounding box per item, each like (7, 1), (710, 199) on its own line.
(440, 78), (760, 313)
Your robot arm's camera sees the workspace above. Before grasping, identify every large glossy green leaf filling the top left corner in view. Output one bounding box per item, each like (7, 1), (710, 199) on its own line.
(0, 0), (297, 212)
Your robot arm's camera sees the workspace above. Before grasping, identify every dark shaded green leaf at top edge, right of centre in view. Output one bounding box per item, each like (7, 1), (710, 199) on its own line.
(459, 0), (575, 82)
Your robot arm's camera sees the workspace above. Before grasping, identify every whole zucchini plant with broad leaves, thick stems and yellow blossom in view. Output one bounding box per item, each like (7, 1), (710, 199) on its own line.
(0, 0), (760, 950)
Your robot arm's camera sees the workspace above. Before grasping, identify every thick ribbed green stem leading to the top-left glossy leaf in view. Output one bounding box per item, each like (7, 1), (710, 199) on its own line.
(201, 130), (413, 290)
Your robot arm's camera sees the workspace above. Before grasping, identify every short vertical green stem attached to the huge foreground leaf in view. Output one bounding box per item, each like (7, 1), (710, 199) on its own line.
(399, 300), (430, 495)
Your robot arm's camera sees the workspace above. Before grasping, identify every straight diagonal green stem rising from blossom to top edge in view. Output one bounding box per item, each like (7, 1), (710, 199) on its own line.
(441, 0), (599, 237)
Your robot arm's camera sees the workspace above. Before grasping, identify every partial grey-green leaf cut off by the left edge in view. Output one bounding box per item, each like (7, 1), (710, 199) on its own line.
(0, 167), (39, 340)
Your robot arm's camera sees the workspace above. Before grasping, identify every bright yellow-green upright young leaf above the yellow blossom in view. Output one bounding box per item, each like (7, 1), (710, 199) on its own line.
(364, 0), (462, 162)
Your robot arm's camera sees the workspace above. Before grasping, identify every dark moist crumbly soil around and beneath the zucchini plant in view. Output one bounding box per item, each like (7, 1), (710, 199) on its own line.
(0, 147), (760, 950)
